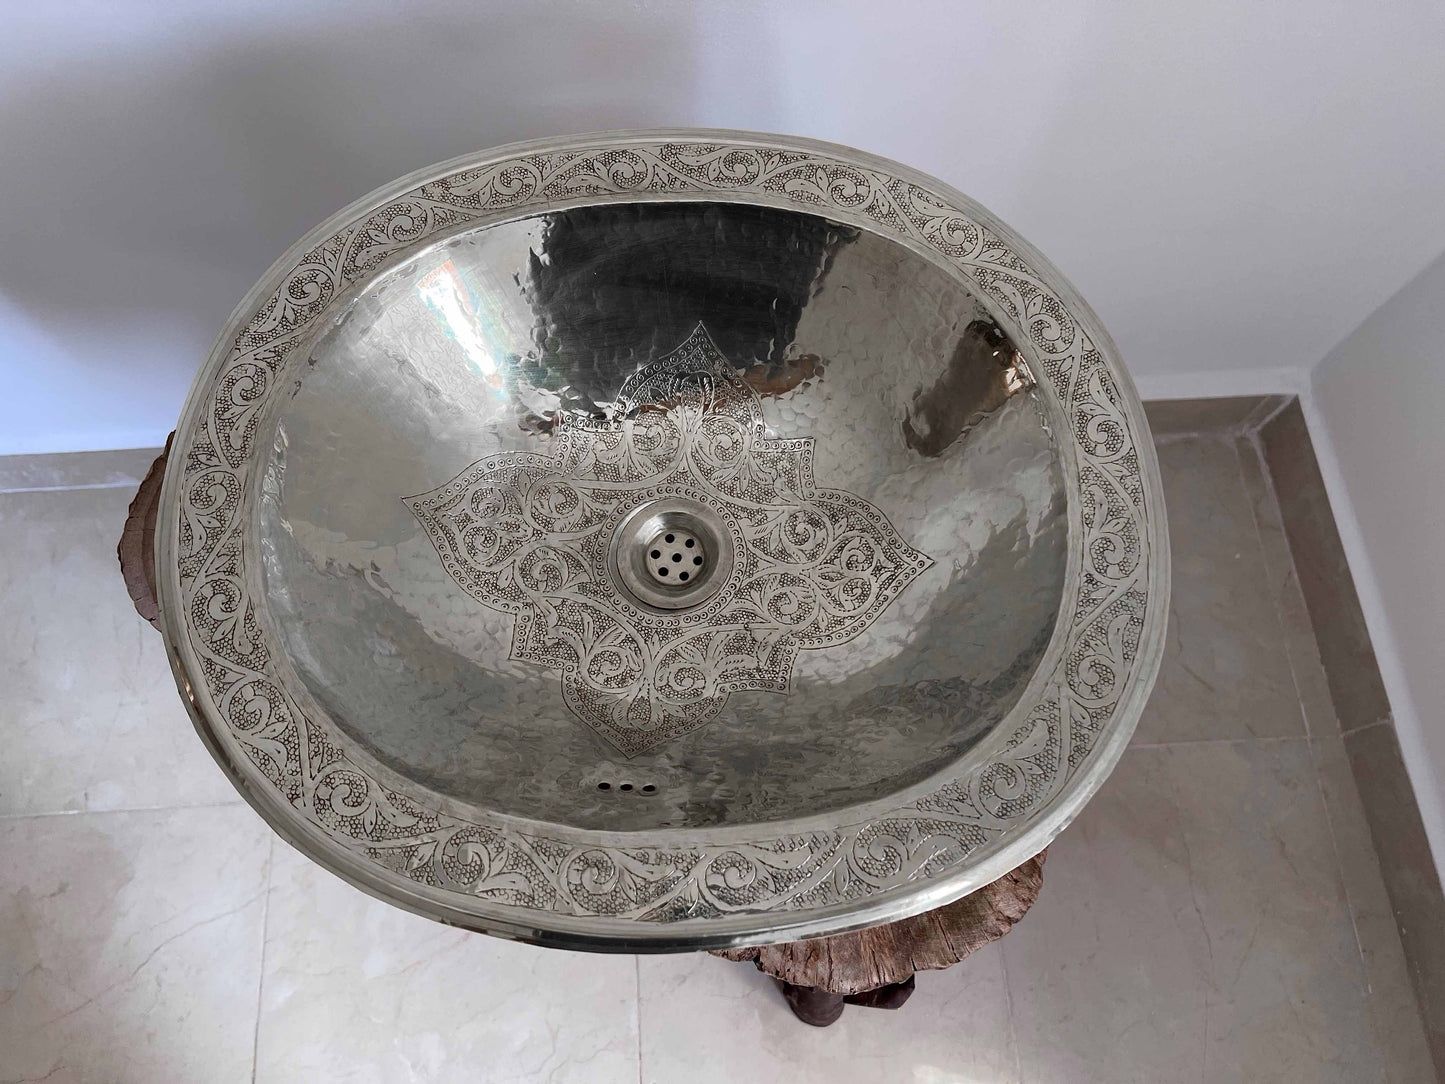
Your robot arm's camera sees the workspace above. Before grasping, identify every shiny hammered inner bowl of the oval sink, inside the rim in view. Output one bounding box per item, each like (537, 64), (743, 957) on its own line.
(256, 202), (1068, 833)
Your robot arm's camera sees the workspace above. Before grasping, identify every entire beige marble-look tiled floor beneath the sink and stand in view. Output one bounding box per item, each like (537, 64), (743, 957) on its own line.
(0, 436), (1433, 1084)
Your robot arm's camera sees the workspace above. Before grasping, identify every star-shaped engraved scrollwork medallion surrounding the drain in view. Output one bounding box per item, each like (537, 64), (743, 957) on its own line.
(406, 324), (933, 756)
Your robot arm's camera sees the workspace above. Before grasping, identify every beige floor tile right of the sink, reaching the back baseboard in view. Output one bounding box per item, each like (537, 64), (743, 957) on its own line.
(1134, 436), (1305, 743)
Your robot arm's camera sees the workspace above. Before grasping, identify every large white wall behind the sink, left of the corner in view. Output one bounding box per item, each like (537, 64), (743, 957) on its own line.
(0, 0), (1445, 454)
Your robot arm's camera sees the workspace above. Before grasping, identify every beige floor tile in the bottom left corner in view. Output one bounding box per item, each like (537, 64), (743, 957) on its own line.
(0, 805), (270, 1084)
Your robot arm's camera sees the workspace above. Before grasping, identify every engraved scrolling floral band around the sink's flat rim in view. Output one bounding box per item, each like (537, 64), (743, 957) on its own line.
(168, 137), (1162, 929)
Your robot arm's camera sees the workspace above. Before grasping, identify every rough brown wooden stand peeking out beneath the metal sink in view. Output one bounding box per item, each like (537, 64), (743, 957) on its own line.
(116, 434), (1048, 1028)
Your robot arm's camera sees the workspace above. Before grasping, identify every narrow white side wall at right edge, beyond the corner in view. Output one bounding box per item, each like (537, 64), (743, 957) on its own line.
(1308, 256), (1445, 867)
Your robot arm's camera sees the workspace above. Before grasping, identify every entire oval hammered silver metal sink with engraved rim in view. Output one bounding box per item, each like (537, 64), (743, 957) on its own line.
(158, 132), (1168, 951)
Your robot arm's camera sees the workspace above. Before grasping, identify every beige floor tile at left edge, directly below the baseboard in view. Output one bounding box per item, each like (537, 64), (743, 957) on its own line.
(0, 489), (237, 814)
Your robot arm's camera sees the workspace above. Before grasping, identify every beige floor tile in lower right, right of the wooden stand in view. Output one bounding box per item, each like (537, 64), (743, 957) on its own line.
(1001, 741), (1384, 1084)
